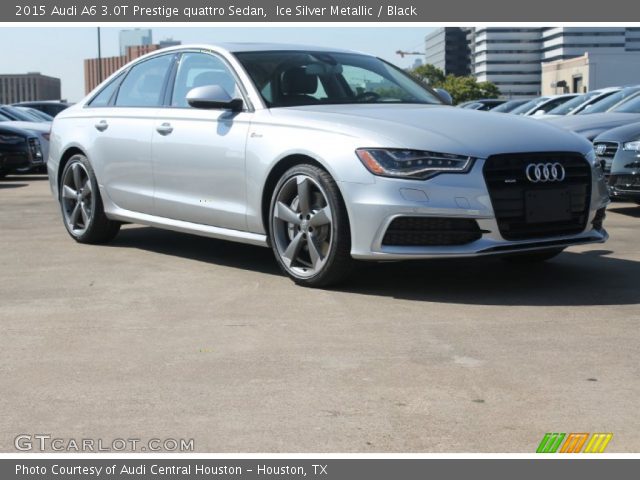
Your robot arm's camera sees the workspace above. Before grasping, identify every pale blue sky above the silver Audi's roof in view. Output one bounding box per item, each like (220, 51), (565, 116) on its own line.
(0, 25), (433, 102)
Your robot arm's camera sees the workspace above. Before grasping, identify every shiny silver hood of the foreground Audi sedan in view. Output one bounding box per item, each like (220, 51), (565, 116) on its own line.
(264, 104), (591, 158)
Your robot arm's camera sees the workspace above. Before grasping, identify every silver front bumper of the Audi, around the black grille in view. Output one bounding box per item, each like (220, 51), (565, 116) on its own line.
(340, 159), (609, 260)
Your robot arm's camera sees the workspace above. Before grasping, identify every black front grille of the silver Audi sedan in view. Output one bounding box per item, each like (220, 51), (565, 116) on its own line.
(483, 152), (591, 240)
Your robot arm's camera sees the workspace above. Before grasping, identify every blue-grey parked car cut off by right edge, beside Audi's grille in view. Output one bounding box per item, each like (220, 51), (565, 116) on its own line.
(593, 122), (640, 204)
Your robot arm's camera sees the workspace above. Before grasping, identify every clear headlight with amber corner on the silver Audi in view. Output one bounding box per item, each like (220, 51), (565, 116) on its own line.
(356, 148), (473, 179)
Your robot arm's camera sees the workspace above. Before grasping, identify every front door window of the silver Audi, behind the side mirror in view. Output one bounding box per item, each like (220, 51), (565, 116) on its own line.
(171, 52), (240, 107)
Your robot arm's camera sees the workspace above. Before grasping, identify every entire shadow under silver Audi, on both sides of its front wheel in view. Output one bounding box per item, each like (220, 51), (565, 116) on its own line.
(110, 226), (640, 306)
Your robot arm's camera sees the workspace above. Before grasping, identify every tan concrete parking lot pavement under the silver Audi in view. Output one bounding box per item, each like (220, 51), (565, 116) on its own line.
(0, 175), (640, 452)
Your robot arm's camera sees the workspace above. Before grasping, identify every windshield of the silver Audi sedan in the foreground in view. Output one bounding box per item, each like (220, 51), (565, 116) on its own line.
(235, 51), (442, 107)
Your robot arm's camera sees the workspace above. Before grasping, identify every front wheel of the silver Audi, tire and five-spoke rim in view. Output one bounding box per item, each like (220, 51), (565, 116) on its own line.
(269, 164), (354, 287)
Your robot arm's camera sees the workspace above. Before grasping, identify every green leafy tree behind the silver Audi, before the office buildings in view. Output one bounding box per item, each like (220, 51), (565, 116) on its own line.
(409, 64), (500, 105)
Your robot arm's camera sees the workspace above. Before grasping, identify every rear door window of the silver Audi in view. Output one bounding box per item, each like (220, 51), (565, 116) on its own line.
(116, 55), (173, 107)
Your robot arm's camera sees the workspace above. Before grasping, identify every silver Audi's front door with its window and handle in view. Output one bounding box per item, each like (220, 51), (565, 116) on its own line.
(152, 52), (252, 230)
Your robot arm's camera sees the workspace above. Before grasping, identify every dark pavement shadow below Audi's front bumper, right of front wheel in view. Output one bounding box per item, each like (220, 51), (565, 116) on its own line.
(343, 250), (640, 306)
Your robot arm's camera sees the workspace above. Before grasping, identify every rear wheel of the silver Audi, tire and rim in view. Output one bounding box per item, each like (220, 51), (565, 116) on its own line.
(59, 155), (120, 244)
